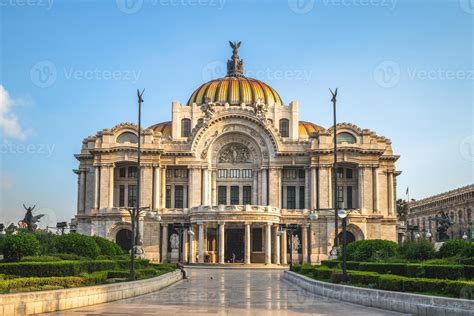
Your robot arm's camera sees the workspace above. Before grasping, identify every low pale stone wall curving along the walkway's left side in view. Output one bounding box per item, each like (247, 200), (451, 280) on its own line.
(0, 270), (182, 315)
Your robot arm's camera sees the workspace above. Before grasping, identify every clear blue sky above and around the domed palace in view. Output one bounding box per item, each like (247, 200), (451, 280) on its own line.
(0, 0), (474, 227)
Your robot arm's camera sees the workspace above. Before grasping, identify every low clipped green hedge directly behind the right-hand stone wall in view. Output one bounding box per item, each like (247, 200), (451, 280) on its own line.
(313, 266), (474, 298)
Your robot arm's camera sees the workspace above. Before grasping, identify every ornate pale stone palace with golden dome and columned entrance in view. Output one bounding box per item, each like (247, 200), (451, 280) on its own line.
(74, 43), (400, 264)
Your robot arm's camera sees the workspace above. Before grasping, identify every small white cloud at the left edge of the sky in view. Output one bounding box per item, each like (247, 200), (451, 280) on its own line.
(0, 84), (30, 140)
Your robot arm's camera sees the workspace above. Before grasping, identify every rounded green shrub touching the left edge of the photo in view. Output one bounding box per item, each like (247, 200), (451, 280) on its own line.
(3, 233), (40, 261)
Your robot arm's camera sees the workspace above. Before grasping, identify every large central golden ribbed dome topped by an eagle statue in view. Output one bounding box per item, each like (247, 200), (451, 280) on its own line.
(187, 42), (283, 106)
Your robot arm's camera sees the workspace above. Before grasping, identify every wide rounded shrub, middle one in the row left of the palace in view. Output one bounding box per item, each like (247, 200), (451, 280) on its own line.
(53, 233), (100, 259)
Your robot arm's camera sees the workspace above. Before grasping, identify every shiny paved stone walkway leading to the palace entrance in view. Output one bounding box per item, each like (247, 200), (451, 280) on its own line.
(44, 268), (408, 316)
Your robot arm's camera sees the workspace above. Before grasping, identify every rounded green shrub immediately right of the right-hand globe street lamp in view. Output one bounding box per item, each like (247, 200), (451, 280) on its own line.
(346, 239), (397, 261)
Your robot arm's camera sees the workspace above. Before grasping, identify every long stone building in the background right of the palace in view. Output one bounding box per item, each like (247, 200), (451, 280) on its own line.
(407, 184), (474, 242)
